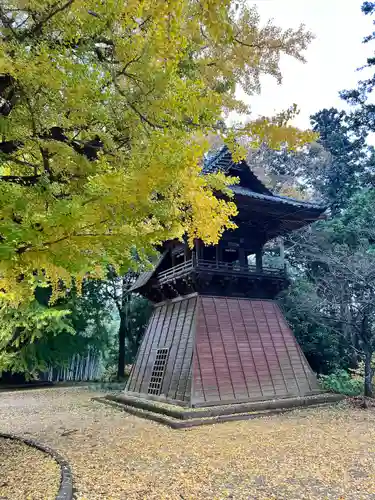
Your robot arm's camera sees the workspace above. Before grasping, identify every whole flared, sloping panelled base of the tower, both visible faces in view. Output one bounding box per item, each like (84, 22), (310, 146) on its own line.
(125, 295), (320, 407)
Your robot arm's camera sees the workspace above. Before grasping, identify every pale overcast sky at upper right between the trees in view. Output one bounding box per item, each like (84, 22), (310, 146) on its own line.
(236, 0), (375, 128)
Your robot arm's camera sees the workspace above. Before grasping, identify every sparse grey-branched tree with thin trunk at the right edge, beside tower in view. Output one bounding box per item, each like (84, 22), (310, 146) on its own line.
(284, 189), (375, 396)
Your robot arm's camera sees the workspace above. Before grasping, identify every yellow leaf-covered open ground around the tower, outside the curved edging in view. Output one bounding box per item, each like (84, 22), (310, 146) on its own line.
(0, 388), (375, 500)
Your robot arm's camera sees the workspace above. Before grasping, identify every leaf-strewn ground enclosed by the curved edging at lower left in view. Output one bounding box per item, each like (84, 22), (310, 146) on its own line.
(0, 437), (60, 500)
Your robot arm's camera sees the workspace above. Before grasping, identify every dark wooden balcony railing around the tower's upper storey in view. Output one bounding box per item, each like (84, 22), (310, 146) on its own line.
(157, 258), (286, 283)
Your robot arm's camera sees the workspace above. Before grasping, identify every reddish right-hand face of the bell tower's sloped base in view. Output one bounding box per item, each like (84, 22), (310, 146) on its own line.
(192, 297), (319, 405)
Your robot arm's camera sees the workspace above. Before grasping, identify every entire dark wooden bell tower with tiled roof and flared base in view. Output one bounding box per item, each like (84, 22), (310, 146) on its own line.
(126, 147), (324, 406)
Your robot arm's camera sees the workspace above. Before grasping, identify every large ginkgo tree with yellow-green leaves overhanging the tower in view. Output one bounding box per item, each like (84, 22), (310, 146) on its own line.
(0, 0), (311, 302)
